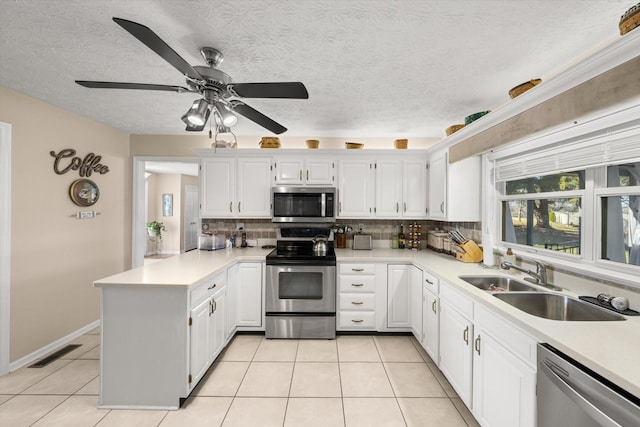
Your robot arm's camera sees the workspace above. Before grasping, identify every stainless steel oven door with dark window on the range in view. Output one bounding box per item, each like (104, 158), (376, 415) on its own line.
(266, 264), (336, 314)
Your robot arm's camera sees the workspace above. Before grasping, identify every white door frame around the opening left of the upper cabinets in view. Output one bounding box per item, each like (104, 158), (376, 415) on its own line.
(131, 156), (200, 268)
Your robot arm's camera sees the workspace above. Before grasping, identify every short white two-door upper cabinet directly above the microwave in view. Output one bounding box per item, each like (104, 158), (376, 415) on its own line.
(274, 156), (336, 185)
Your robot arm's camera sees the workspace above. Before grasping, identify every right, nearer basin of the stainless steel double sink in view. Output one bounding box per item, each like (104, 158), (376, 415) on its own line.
(493, 292), (626, 321)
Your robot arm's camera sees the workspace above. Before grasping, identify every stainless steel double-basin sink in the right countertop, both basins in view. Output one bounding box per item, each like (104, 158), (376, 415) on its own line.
(459, 276), (626, 321)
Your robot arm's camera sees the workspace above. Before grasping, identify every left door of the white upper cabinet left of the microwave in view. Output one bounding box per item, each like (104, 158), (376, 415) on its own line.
(200, 158), (236, 218)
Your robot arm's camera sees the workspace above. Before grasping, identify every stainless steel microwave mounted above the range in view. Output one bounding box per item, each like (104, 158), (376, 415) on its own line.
(271, 187), (336, 223)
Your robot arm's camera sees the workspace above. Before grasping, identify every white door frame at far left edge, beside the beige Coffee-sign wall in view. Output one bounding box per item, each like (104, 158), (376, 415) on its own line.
(0, 122), (11, 375)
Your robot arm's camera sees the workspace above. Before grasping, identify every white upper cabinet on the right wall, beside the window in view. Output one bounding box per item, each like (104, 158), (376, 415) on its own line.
(427, 148), (481, 221)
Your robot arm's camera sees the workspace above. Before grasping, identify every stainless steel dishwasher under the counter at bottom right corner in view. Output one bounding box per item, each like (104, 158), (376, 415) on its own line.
(537, 344), (640, 427)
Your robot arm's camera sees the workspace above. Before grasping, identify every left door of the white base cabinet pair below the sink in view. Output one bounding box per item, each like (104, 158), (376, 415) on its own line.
(439, 299), (473, 408)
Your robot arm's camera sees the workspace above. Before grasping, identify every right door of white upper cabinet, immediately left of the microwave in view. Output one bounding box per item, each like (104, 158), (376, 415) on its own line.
(235, 158), (271, 218)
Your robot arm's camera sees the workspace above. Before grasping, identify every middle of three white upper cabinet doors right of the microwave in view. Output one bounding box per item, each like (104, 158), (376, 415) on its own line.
(375, 160), (402, 218)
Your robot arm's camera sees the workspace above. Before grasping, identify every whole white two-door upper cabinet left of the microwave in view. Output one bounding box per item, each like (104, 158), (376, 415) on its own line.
(200, 157), (271, 218)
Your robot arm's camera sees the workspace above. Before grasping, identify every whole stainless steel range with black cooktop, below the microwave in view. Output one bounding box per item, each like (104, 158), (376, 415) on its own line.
(265, 225), (336, 339)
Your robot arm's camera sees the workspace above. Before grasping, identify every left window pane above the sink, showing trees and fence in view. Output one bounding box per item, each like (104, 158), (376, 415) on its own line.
(502, 171), (585, 255)
